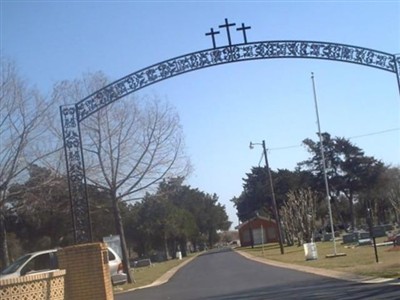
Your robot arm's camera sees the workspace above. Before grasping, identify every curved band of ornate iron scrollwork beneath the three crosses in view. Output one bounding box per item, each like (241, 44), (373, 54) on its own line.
(77, 41), (399, 121)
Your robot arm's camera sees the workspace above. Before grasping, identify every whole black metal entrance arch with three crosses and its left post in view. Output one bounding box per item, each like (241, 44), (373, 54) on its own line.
(60, 19), (400, 244)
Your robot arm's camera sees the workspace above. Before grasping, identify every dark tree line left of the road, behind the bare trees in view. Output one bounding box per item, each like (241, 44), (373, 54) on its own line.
(5, 165), (231, 259)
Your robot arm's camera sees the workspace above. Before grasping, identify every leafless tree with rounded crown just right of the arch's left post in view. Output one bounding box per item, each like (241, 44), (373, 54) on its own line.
(57, 73), (190, 282)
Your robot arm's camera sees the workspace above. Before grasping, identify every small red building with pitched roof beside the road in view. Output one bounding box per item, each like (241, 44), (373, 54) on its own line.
(238, 216), (279, 247)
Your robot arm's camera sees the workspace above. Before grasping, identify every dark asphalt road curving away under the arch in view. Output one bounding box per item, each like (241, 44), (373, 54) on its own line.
(115, 249), (400, 300)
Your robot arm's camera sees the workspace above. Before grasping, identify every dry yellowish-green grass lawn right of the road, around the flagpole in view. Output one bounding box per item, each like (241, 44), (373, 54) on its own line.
(238, 238), (400, 278)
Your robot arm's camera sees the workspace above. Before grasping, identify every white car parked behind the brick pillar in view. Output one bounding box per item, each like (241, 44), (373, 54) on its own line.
(0, 247), (127, 285)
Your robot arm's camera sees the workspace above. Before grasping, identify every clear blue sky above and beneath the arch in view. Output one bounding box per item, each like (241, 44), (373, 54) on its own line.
(0, 0), (400, 229)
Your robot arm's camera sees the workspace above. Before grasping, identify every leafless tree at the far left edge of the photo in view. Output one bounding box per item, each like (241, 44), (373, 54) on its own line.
(0, 57), (51, 266)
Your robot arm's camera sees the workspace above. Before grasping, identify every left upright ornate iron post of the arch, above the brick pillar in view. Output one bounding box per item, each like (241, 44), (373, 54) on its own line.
(60, 105), (92, 244)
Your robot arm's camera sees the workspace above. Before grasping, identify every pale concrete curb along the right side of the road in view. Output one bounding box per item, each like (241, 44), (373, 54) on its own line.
(235, 250), (400, 285)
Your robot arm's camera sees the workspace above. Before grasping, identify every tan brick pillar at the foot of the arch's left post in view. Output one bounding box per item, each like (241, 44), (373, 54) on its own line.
(58, 243), (114, 300)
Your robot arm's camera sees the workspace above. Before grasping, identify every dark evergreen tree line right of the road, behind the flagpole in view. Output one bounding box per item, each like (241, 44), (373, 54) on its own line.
(231, 133), (400, 245)
